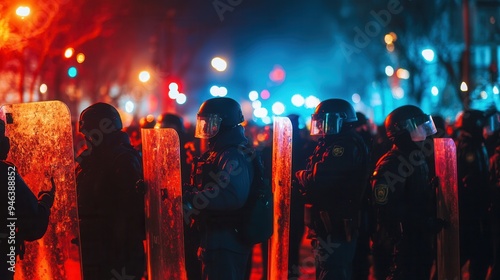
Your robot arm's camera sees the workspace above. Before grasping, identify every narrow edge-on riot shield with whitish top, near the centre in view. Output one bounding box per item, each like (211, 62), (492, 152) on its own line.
(268, 117), (293, 279)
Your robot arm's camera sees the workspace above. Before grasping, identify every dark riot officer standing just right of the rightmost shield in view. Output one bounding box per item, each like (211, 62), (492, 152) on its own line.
(455, 110), (491, 279)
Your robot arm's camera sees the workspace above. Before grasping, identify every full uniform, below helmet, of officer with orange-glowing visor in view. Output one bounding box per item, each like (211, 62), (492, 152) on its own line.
(185, 127), (253, 280)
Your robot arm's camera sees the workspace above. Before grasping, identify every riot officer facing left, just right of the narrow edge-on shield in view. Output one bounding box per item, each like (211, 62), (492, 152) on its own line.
(295, 99), (369, 279)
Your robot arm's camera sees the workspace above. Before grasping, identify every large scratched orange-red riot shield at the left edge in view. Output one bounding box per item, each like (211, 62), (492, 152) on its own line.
(1, 101), (82, 280)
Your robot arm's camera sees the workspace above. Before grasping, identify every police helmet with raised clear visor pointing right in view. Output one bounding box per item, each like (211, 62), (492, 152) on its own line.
(384, 105), (437, 142)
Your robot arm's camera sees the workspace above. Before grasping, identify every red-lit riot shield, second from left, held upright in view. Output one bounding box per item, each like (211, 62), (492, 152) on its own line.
(141, 128), (187, 280)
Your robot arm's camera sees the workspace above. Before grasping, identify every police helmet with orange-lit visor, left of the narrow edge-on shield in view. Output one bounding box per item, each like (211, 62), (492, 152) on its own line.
(194, 97), (244, 139)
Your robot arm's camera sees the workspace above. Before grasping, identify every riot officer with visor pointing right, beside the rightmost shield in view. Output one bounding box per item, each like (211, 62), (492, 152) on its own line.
(371, 105), (442, 279)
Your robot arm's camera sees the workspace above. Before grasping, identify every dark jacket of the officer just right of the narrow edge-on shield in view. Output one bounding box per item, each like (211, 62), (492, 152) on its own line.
(303, 131), (369, 239)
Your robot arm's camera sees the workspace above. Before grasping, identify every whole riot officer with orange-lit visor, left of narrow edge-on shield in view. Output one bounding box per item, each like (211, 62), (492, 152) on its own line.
(184, 97), (253, 280)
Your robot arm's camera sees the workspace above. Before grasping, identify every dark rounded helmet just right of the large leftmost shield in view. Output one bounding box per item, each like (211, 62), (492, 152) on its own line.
(78, 102), (123, 134)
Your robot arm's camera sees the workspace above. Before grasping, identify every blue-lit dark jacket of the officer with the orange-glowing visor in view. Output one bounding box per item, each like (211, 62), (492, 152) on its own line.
(186, 126), (253, 253)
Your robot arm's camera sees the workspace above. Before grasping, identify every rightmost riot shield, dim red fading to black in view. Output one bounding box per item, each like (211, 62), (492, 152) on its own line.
(434, 138), (460, 280)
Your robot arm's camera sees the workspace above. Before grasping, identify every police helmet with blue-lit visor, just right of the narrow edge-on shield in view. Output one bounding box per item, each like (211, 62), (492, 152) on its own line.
(311, 98), (358, 135)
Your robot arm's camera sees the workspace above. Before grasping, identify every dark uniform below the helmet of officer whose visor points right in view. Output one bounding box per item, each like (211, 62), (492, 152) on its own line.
(371, 142), (435, 279)
